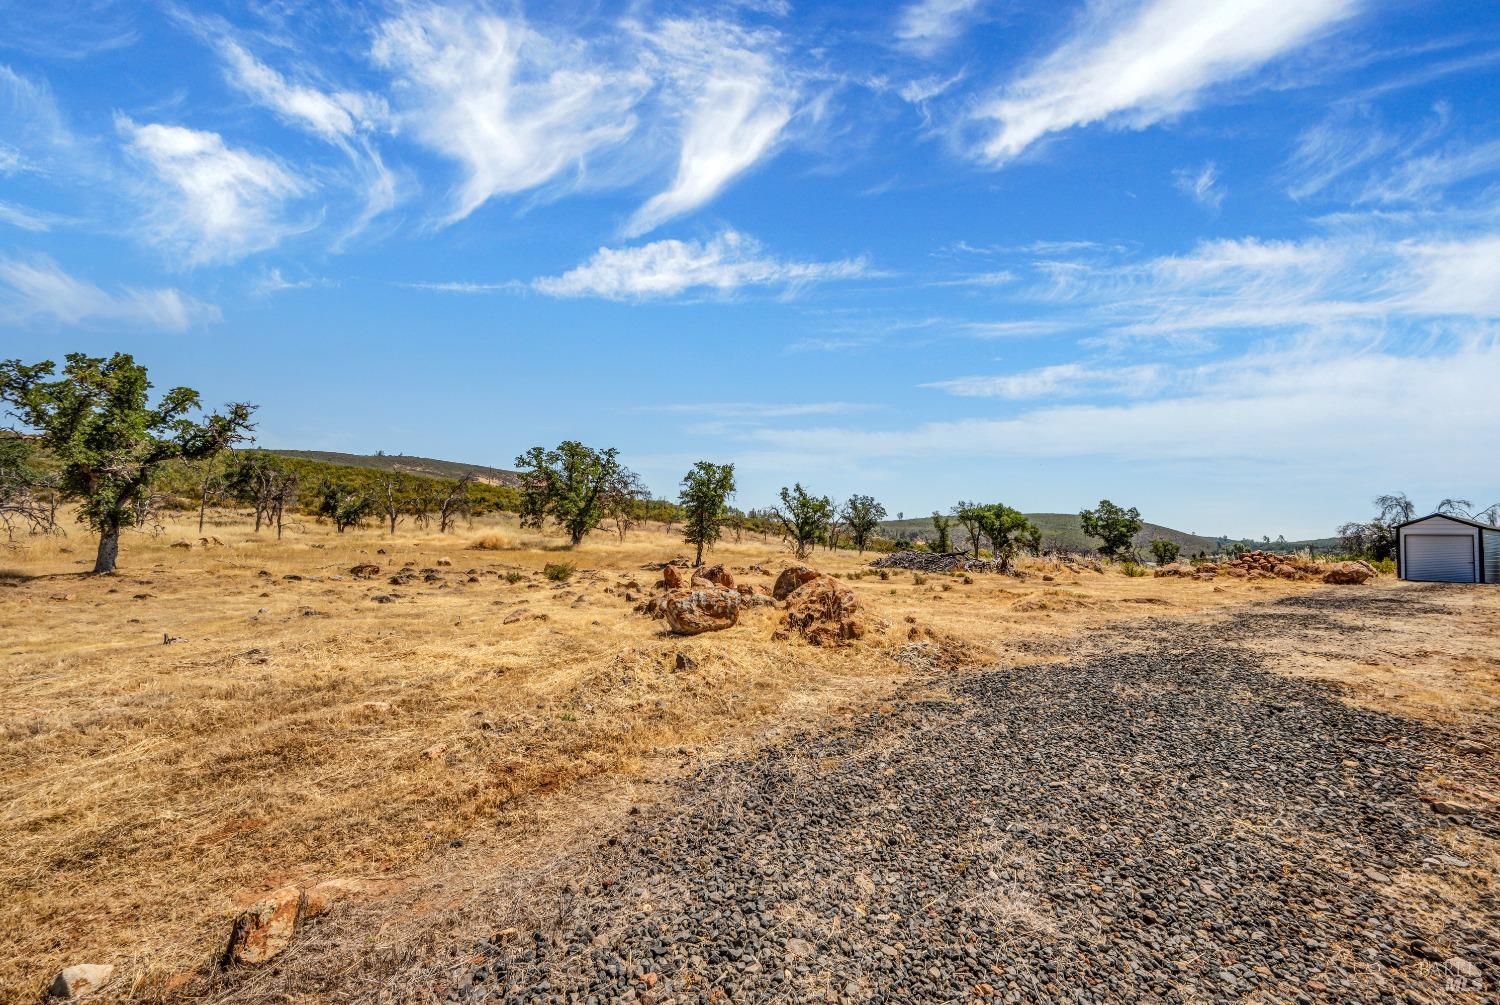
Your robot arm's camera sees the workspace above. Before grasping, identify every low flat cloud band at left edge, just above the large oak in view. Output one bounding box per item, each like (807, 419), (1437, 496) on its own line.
(0, 257), (221, 333)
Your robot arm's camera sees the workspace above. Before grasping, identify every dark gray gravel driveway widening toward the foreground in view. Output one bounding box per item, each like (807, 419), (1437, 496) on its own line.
(434, 591), (1500, 1005)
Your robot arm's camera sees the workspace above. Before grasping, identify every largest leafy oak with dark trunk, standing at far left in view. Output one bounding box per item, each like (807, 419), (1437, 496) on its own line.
(0, 353), (255, 573)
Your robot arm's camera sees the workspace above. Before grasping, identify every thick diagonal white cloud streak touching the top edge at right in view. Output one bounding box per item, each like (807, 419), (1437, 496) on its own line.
(977, 0), (1361, 165)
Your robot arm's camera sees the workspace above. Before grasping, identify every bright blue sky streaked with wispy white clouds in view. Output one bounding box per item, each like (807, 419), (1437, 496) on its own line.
(0, 0), (1500, 537)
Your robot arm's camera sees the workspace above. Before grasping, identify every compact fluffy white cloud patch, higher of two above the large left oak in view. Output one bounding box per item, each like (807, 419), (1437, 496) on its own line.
(116, 116), (309, 266)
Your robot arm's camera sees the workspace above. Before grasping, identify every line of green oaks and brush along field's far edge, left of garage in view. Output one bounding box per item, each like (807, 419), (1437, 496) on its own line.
(0, 353), (1175, 573)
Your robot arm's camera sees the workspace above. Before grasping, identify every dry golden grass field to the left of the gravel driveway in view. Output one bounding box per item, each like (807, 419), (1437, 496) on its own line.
(0, 515), (1458, 1001)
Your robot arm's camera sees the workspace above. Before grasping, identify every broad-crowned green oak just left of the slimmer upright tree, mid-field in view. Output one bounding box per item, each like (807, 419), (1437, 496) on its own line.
(516, 440), (641, 546)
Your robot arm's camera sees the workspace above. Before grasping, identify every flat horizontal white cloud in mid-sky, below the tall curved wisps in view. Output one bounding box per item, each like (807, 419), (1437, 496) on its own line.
(531, 231), (869, 300)
